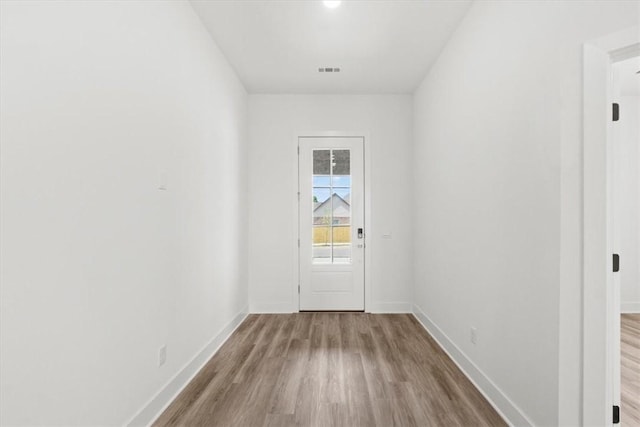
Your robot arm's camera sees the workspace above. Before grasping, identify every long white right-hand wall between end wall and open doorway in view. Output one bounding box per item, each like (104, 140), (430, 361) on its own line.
(414, 1), (638, 425)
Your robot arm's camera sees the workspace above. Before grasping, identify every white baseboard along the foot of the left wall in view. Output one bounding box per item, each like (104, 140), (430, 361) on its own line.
(125, 307), (248, 426)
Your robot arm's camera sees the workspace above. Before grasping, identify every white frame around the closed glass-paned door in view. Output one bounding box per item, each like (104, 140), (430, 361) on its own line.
(291, 131), (373, 313)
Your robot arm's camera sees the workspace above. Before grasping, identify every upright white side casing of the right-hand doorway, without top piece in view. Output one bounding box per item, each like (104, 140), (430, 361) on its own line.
(582, 41), (613, 426)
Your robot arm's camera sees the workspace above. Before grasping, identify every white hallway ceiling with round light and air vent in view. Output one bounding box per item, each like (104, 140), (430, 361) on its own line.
(191, 0), (471, 93)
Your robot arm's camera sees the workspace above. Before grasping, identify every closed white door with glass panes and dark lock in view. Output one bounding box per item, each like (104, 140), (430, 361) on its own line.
(298, 137), (365, 311)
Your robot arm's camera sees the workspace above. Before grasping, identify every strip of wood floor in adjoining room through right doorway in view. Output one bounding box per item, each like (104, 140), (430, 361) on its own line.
(620, 314), (640, 427)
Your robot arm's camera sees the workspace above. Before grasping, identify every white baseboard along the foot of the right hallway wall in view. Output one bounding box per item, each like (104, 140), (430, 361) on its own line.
(413, 305), (533, 426)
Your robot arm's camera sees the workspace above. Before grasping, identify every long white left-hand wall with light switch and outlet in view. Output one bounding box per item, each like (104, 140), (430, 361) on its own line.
(0, 1), (248, 425)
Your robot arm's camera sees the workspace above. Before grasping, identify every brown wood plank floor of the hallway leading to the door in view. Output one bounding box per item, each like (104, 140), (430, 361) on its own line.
(154, 313), (506, 427)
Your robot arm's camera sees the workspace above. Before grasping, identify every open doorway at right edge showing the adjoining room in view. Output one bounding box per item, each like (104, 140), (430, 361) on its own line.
(611, 57), (640, 426)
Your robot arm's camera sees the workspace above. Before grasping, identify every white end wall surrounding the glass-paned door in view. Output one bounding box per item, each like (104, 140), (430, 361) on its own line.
(249, 95), (413, 312)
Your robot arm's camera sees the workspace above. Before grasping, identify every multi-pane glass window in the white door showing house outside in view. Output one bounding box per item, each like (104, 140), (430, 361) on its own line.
(312, 150), (351, 264)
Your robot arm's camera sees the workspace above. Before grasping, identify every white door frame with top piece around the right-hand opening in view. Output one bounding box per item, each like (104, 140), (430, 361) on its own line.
(582, 27), (640, 425)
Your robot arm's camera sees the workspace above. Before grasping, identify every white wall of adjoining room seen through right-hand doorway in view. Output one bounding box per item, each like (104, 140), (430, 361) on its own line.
(613, 96), (640, 313)
